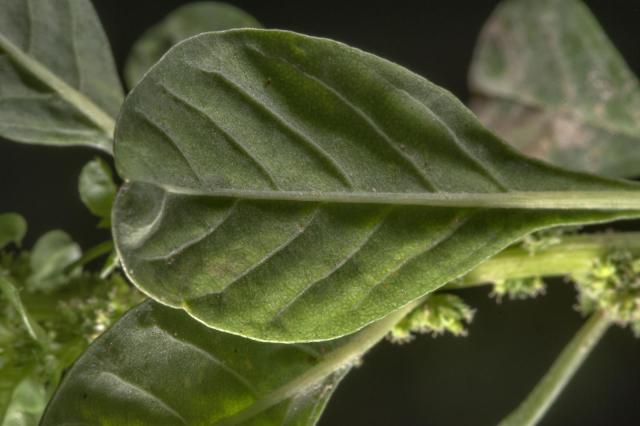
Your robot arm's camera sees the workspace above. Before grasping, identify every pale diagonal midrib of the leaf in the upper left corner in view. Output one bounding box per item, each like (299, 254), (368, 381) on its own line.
(0, 34), (115, 153)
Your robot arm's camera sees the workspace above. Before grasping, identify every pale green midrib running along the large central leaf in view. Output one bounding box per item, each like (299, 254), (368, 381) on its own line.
(141, 183), (640, 210)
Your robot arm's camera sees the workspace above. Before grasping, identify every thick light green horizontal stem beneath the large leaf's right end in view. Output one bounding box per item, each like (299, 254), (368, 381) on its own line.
(447, 232), (640, 289)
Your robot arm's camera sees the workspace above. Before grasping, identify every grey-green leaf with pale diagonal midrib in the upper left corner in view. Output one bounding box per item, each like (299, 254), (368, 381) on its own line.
(0, 0), (123, 152)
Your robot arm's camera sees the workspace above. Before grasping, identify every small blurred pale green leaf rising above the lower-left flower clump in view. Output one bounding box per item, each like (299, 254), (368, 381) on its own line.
(27, 230), (82, 291)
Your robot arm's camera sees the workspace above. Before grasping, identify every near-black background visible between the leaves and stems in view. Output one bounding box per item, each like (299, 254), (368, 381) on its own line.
(0, 0), (640, 426)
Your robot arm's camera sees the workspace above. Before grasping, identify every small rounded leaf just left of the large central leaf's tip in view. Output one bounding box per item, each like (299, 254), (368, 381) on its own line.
(78, 158), (118, 226)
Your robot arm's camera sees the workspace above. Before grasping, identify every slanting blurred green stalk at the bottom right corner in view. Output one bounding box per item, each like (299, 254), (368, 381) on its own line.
(499, 312), (610, 426)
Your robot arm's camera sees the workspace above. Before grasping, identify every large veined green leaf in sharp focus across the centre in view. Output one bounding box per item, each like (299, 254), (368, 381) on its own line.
(114, 30), (640, 342)
